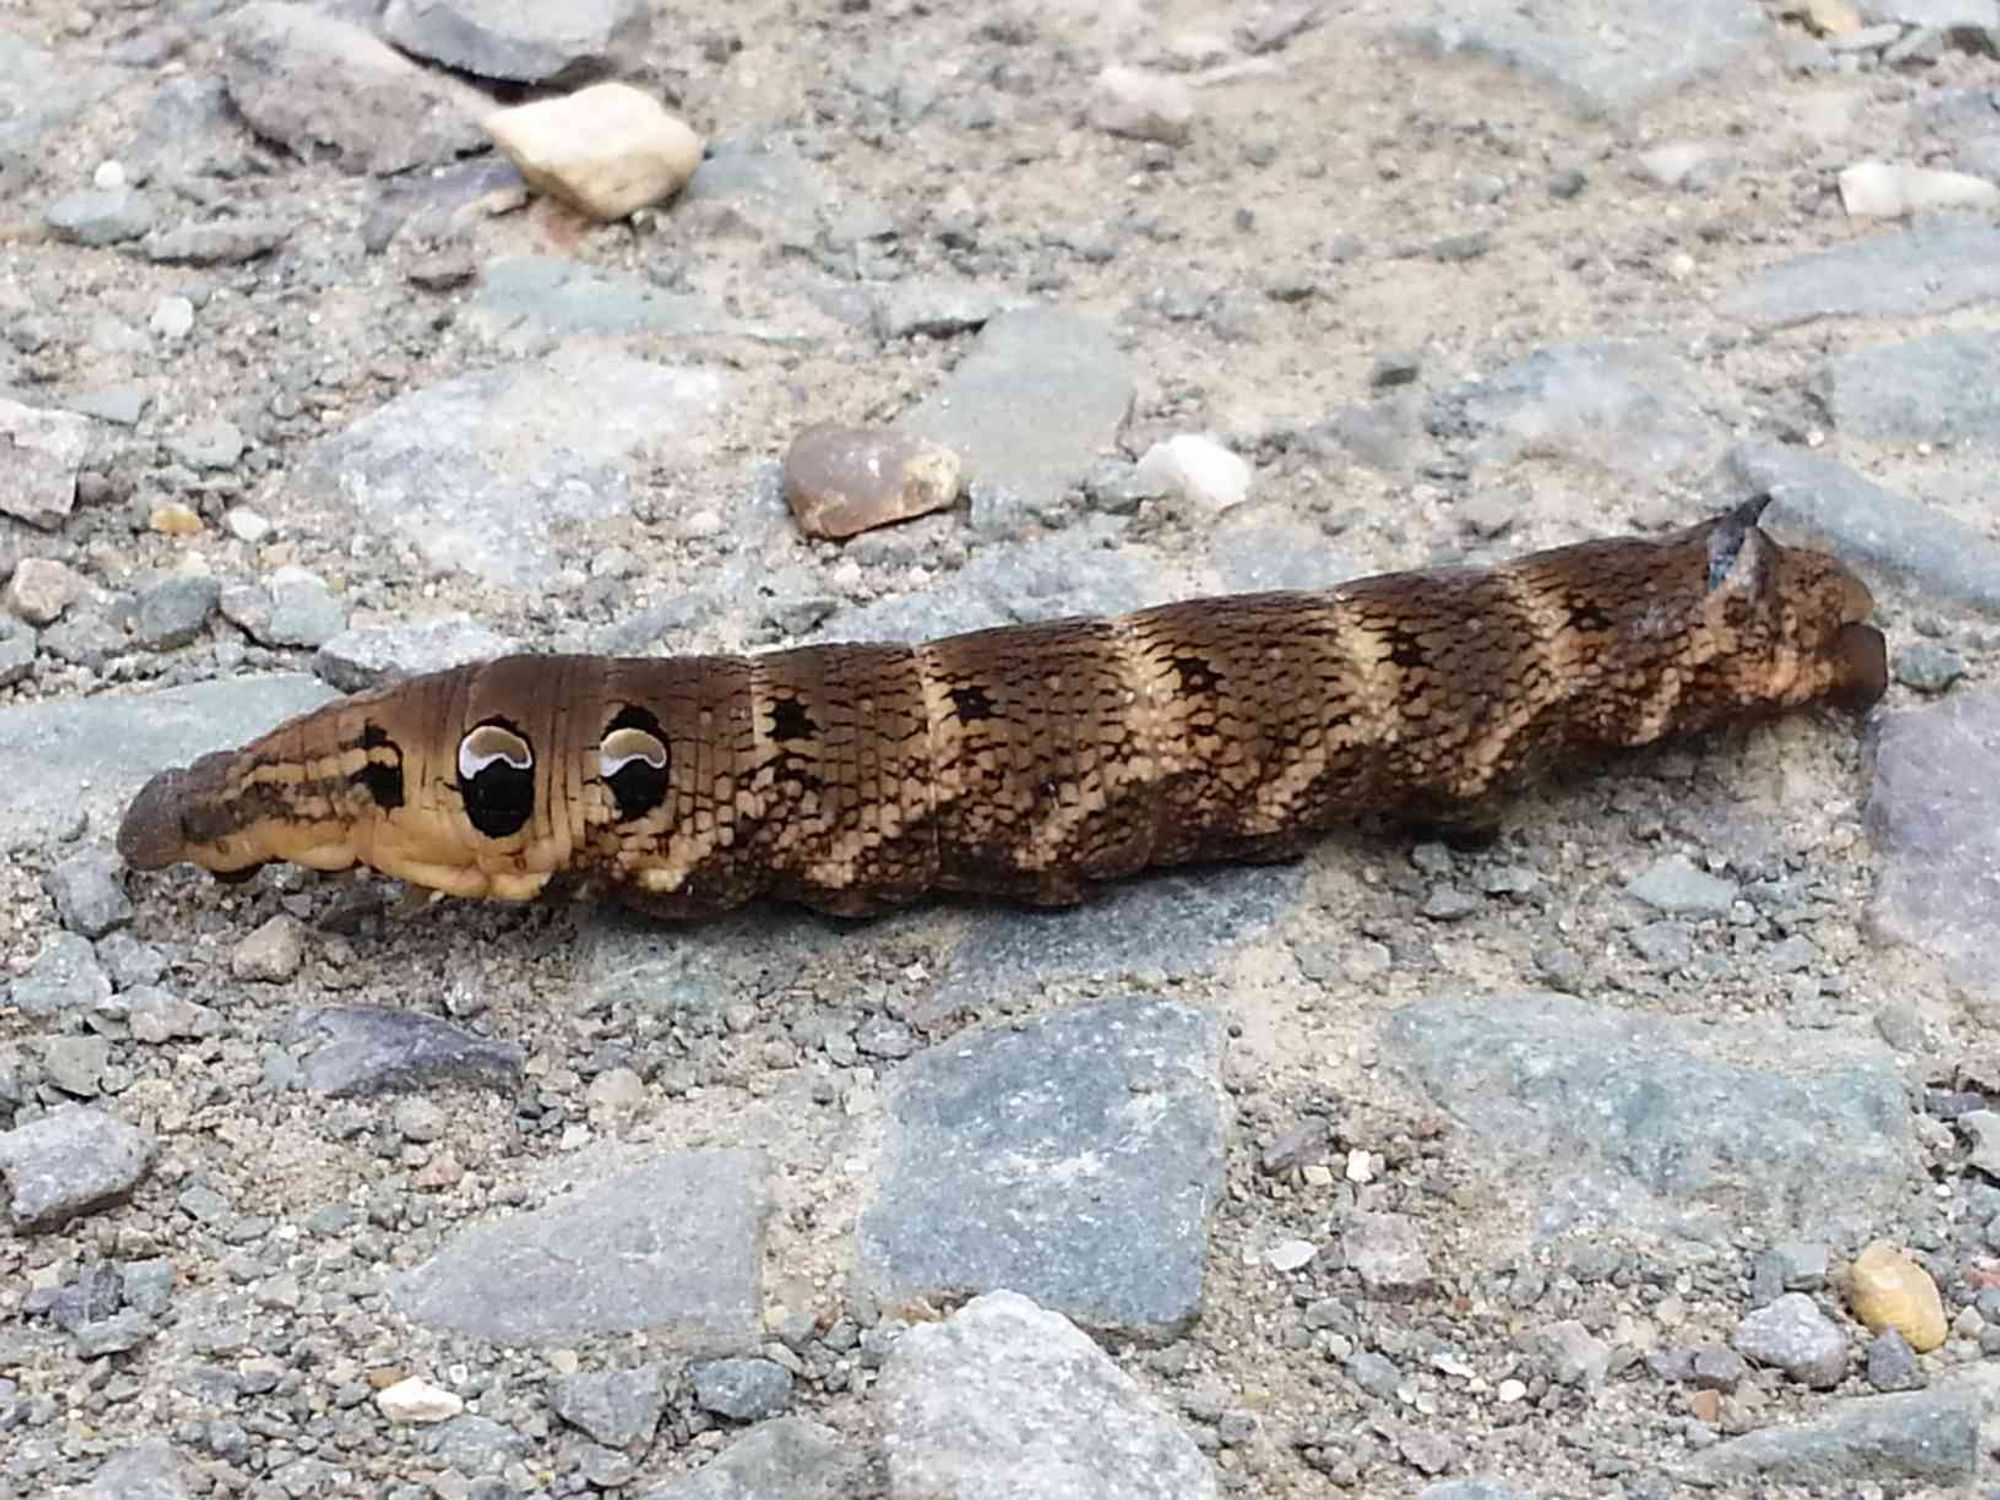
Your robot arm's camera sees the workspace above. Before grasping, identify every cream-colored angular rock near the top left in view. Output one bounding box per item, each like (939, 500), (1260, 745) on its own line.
(486, 84), (702, 222)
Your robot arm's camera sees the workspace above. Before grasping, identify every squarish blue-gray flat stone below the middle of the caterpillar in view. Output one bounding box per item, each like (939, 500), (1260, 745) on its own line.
(860, 1000), (1222, 1334)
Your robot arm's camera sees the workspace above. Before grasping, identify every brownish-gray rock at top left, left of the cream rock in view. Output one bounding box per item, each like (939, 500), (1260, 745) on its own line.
(224, 0), (492, 174)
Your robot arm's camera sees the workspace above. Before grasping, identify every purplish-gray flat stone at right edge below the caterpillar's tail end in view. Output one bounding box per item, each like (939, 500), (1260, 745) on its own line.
(1868, 690), (2000, 1000)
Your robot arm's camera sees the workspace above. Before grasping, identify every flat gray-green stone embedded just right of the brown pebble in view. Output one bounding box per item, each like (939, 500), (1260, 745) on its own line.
(896, 308), (1136, 532)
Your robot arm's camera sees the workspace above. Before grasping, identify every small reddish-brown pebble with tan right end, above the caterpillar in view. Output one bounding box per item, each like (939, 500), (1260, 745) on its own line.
(784, 422), (958, 538)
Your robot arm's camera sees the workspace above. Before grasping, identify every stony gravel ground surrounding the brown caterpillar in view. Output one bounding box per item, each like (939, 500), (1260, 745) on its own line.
(0, 0), (2000, 1500)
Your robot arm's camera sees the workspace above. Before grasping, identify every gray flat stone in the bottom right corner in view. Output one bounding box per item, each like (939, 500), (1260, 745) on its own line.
(1688, 1390), (1980, 1490)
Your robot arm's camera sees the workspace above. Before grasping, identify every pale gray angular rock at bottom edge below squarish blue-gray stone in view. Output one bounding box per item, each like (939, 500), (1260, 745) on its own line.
(880, 1292), (1218, 1500)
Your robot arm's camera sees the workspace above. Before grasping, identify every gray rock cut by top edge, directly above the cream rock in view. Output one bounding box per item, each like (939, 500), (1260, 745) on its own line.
(382, 0), (652, 84)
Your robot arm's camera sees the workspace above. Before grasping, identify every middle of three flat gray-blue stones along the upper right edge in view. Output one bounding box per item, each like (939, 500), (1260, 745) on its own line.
(1822, 332), (2000, 444)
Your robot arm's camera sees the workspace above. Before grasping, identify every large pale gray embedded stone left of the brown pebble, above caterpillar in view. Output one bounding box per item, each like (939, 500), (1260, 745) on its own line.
(298, 350), (730, 586)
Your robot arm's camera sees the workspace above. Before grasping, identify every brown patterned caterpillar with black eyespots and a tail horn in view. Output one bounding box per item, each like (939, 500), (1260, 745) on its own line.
(118, 500), (1886, 916)
